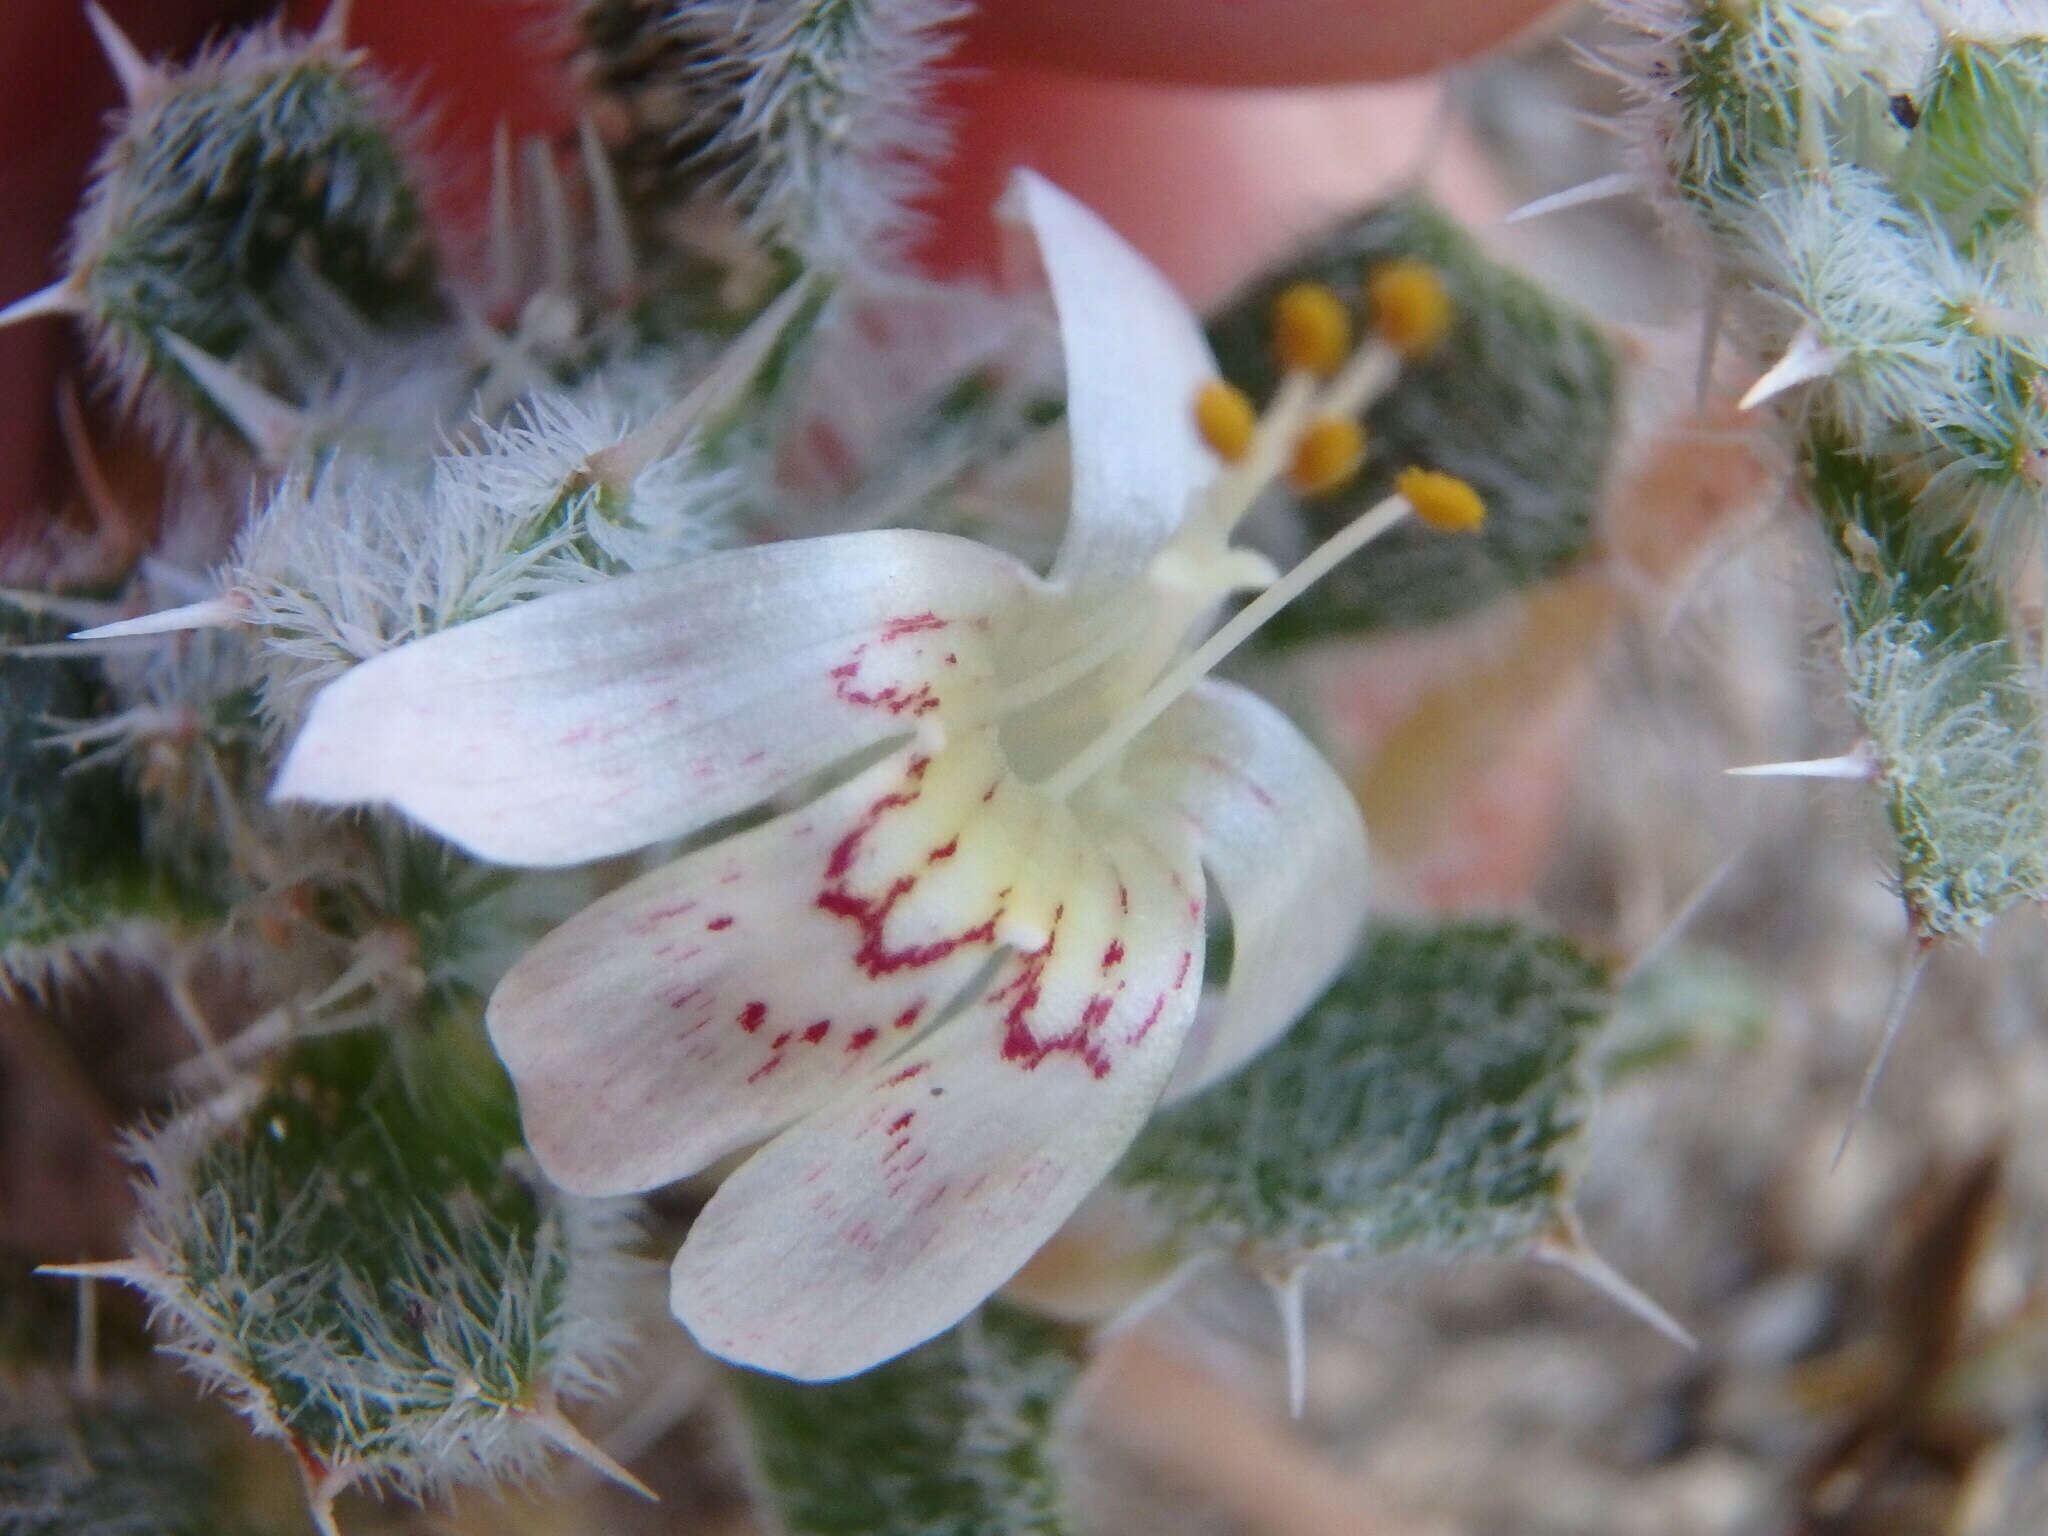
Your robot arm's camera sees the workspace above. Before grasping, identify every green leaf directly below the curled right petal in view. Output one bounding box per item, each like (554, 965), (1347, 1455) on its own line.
(1116, 922), (1610, 1264)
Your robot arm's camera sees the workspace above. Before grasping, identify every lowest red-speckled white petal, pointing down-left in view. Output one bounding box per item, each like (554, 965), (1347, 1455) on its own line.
(670, 813), (1202, 1380)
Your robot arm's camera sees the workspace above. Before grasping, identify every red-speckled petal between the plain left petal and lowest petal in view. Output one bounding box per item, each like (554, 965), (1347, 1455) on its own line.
(487, 731), (1047, 1194)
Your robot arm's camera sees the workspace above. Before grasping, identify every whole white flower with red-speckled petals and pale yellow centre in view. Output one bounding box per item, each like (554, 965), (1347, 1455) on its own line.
(276, 176), (1409, 1378)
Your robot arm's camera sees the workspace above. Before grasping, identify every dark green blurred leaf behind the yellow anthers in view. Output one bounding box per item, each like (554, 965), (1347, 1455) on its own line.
(1208, 197), (1616, 645)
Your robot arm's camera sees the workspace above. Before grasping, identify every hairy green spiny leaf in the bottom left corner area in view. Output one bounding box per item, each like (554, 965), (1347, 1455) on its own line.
(116, 1028), (629, 1493)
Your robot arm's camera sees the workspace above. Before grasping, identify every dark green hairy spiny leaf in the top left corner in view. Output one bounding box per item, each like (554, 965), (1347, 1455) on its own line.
(70, 20), (442, 442)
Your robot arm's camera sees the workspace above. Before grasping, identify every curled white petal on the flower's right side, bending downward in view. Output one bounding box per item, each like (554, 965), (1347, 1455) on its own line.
(1124, 682), (1368, 1098)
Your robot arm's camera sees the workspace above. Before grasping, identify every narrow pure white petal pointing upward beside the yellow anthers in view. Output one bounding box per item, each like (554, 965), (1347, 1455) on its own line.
(1010, 170), (1217, 586)
